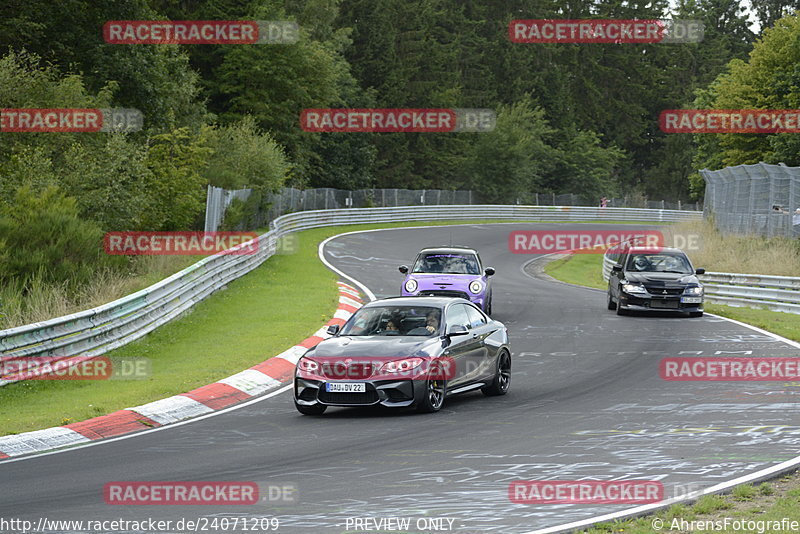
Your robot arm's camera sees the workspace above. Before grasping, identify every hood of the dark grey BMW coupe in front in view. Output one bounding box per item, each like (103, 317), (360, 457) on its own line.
(308, 336), (442, 358)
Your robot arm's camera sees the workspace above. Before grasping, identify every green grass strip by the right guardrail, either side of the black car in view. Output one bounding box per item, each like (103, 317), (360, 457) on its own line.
(544, 254), (800, 341)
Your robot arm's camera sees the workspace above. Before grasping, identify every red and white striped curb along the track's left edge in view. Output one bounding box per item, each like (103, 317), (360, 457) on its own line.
(0, 282), (363, 459)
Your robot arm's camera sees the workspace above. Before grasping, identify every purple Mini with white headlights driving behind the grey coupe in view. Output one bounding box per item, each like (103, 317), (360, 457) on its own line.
(400, 246), (494, 314)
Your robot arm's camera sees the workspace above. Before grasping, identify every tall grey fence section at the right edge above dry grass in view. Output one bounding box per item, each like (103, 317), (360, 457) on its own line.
(700, 163), (800, 237)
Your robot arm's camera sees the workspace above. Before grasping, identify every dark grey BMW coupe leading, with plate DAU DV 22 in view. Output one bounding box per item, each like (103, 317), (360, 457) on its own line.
(294, 297), (511, 415)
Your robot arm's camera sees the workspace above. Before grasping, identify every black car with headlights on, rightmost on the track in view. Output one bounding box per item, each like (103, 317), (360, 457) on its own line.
(608, 247), (705, 317)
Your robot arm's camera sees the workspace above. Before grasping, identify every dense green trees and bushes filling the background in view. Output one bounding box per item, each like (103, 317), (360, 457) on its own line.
(0, 0), (800, 296)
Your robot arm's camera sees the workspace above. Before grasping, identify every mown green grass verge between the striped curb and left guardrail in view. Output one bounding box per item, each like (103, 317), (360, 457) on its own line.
(0, 220), (644, 435)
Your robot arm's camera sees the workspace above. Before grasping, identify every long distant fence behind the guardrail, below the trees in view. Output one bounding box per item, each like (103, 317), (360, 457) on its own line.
(205, 186), (699, 232)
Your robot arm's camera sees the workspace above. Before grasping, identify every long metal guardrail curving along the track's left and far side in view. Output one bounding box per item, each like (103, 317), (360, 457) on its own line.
(0, 205), (702, 386)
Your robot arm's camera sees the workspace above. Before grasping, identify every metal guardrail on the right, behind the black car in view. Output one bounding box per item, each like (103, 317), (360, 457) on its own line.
(602, 254), (800, 314)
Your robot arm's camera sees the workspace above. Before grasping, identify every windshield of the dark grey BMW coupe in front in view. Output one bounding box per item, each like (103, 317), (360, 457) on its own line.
(342, 306), (442, 336)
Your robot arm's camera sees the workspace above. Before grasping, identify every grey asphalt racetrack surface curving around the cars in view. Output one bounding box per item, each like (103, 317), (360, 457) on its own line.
(0, 223), (800, 534)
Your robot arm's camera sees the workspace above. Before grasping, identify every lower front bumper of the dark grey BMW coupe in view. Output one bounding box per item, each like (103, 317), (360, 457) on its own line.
(294, 377), (425, 408)
